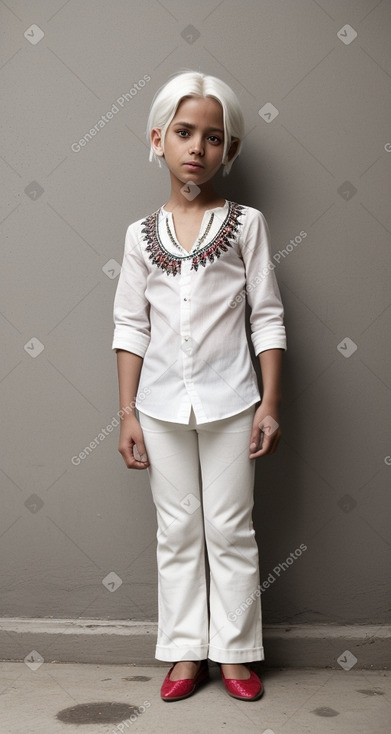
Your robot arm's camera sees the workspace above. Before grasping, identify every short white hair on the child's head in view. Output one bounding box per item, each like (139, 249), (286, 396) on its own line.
(146, 71), (244, 176)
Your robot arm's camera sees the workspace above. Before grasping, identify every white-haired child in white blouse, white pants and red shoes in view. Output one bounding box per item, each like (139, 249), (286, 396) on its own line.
(112, 71), (286, 701)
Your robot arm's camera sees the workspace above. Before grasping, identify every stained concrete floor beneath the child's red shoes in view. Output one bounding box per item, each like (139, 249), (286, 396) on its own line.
(0, 663), (391, 734)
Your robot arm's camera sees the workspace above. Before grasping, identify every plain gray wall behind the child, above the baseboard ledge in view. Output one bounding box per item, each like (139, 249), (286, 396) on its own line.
(0, 0), (391, 625)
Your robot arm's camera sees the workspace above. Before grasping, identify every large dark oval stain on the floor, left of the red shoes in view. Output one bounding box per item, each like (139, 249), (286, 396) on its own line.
(56, 701), (138, 724)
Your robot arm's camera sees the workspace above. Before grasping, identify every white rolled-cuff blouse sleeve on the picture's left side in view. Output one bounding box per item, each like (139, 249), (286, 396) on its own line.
(112, 222), (151, 357)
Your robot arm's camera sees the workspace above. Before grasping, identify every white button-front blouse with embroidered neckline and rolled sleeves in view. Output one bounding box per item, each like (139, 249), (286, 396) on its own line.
(112, 201), (286, 423)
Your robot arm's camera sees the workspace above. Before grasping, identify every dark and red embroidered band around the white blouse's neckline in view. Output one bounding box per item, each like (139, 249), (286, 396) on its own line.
(141, 201), (244, 276)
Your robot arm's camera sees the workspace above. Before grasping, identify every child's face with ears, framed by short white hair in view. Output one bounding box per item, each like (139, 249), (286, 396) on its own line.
(152, 97), (236, 185)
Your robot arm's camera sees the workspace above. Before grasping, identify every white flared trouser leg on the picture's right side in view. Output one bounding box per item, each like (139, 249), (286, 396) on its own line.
(199, 409), (264, 663)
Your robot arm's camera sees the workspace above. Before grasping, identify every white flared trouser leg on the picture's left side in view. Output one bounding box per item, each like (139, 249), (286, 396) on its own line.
(140, 413), (209, 662)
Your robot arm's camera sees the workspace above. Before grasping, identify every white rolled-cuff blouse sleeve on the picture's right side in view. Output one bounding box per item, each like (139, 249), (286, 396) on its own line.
(241, 208), (287, 355)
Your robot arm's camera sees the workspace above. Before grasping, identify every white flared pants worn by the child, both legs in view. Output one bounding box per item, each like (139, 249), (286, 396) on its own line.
(139, 406), (264, 663)
